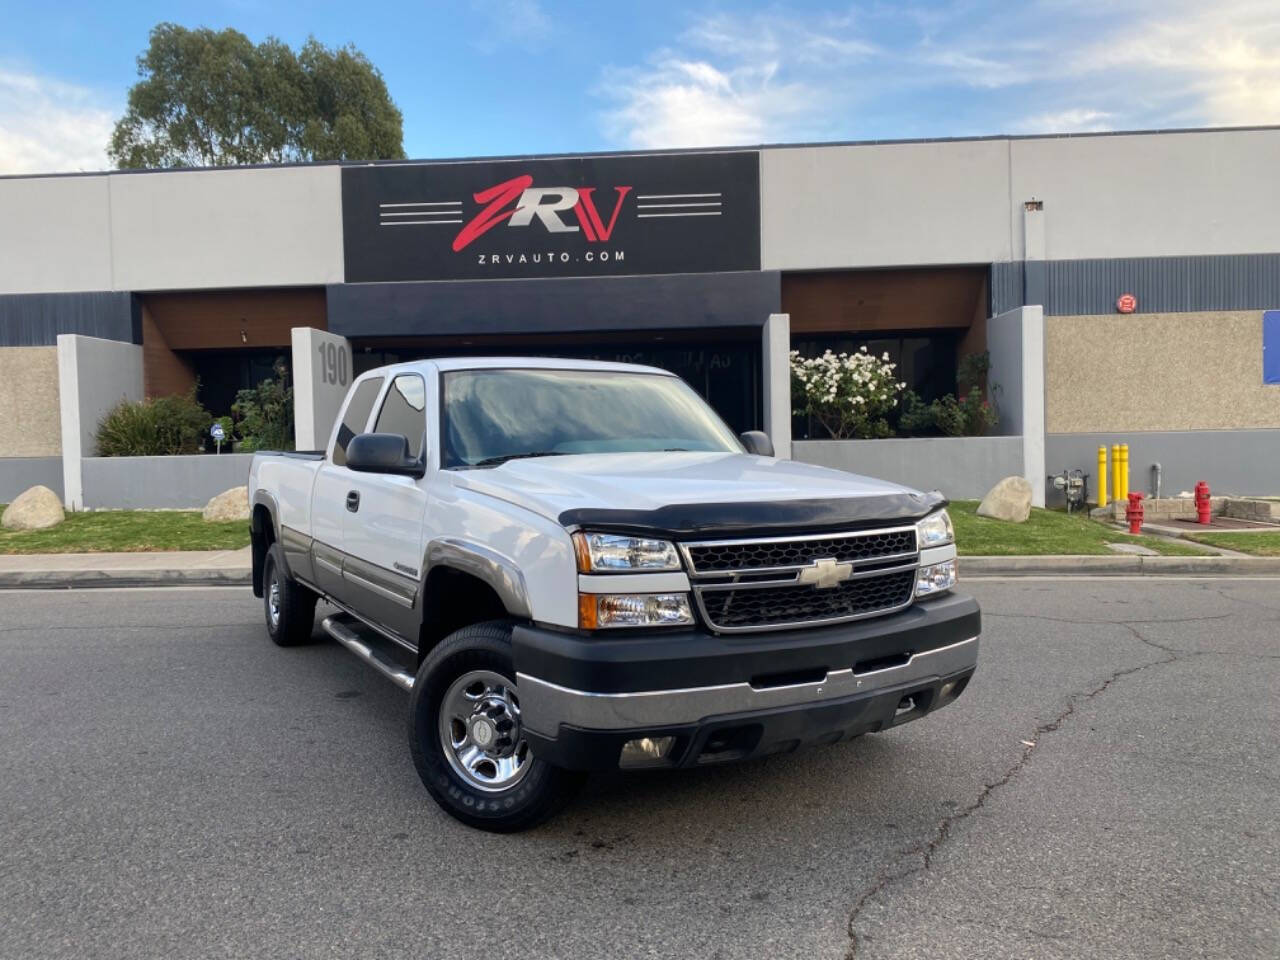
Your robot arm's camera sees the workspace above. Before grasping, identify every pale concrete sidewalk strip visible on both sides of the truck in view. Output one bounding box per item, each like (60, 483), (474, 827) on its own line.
(0, 547), (1280, 589)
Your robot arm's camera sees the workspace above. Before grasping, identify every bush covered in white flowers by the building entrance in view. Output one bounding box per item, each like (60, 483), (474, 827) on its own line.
(791, 347), (906, 440)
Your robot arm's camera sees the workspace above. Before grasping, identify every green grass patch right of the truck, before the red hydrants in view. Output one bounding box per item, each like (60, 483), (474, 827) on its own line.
(948, 500), (1208, 557)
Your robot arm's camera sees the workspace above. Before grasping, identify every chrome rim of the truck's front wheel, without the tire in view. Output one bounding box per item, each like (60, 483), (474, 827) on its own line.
(439, 669), (532, 792)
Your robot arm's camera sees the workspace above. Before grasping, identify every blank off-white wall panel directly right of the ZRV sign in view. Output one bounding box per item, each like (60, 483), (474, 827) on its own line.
(760, 141), (1021, 270)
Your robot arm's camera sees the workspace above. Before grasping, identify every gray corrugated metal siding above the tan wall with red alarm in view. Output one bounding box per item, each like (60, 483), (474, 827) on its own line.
(991, 253), (1280, 316)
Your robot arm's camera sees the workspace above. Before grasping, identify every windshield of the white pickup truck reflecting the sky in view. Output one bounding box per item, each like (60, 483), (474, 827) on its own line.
(443, 370), (742, 467)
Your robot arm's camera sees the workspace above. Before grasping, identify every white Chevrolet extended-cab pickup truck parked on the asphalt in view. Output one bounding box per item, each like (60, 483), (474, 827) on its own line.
(250, 358), (980, 831)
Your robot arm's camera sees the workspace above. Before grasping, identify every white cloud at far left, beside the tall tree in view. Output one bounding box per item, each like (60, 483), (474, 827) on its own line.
(0, 69), (115, 174)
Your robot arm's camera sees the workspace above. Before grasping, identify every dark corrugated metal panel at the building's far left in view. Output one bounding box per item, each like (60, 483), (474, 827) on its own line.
(0, 292), (142, 347)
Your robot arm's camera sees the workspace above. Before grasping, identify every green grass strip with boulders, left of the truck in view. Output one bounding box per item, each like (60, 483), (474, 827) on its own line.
(0, 507), (248, 553)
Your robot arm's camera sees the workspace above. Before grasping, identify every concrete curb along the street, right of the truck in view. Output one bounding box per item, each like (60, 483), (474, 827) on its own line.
(960, 556), (1280, 579)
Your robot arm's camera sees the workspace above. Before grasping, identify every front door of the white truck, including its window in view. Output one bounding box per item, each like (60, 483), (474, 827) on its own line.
(343, 374), (426, 644)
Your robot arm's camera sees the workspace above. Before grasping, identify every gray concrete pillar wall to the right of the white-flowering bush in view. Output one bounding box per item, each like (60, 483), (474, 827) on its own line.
(987, 306), (1044, 507)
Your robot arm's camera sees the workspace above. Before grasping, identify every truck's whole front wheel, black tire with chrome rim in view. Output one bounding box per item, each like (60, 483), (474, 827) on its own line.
(408, 621), (585, 833)
